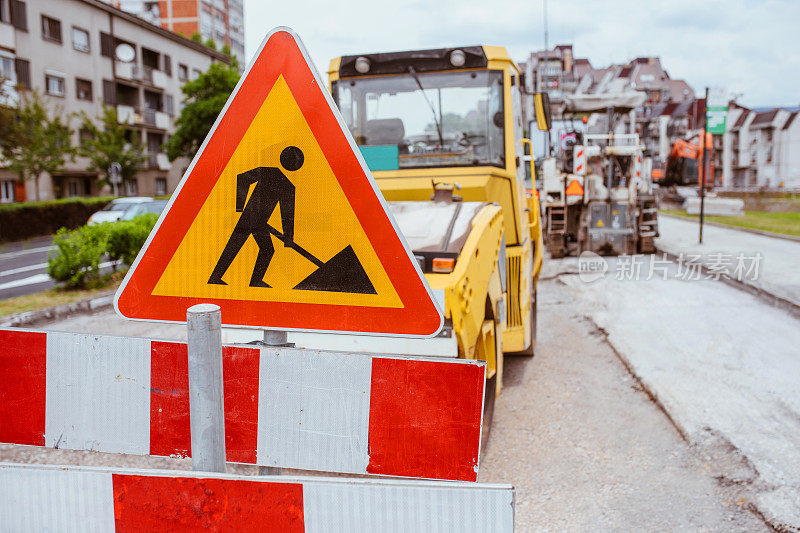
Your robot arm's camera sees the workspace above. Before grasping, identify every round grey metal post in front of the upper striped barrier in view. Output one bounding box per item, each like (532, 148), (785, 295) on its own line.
(186, 304), (225, 473)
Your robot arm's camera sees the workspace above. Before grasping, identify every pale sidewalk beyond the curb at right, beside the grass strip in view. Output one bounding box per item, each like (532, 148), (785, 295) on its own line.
(656, 215), (800, 306)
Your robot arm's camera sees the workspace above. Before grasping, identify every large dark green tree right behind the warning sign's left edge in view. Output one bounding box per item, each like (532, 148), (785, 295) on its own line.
(166, 58), (239, 161)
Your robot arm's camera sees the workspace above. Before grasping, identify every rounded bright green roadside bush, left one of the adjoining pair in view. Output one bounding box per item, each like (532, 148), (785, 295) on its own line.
(47, 224), (109, 288)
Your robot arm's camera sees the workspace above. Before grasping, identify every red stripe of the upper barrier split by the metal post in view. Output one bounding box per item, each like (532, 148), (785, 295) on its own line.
(150, 341), (259, 463)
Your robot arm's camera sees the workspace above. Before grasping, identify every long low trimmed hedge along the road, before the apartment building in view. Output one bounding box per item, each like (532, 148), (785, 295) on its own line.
(0, 197), (113, 242)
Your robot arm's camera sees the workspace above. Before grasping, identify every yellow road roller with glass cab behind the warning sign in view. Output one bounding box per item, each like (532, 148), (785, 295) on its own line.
(328, 46), (543, 392)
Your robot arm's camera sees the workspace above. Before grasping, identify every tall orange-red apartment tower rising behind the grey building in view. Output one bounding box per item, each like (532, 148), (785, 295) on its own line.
(107, 0), (245, 60)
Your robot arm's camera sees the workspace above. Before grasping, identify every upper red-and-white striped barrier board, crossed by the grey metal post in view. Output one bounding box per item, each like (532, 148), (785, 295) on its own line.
(0, 329), (486, 481)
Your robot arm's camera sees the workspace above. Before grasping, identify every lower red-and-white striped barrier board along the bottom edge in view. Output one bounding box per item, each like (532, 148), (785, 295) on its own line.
(0, 463), (514, 533)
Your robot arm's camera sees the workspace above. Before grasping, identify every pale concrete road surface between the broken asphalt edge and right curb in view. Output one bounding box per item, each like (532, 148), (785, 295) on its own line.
(559, 256), (800, 531)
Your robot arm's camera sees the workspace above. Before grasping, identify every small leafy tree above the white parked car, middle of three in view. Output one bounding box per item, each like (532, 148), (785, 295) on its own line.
(78, 106), (147, 190)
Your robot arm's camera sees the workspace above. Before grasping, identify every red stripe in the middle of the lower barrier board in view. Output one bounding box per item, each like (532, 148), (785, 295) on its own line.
(112, 474), (305, 533)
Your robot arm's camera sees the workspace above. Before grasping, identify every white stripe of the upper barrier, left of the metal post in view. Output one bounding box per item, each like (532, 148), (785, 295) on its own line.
(45, 333), (150, 455)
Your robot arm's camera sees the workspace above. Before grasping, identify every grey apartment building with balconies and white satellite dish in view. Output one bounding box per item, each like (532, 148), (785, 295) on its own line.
(0, 0), (228, 202)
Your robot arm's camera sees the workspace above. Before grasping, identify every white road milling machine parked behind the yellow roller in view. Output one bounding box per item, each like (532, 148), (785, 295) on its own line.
(542, 93), (658, 257)
